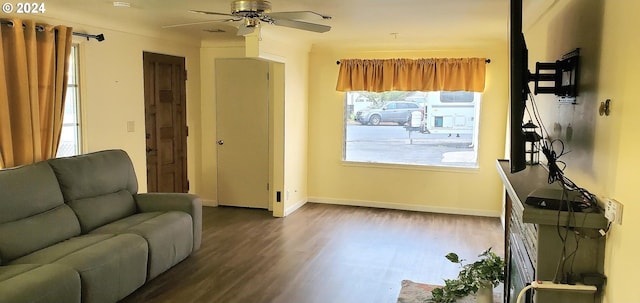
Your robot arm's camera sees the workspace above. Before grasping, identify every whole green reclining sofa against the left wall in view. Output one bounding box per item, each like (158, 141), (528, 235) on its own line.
(0, 150), (202, 303)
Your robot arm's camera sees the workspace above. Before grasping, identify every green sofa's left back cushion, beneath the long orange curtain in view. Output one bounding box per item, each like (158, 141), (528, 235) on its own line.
(0, 162), (80, 264)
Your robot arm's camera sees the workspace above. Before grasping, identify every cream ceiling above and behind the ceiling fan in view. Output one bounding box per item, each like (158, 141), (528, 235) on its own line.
(45, 0), (509, 48)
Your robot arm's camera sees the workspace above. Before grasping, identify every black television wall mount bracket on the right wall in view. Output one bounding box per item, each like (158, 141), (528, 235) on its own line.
(529, 48), (580, 99)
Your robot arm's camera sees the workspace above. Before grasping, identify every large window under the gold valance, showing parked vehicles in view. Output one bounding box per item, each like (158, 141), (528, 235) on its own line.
(343, 91), (481, 167)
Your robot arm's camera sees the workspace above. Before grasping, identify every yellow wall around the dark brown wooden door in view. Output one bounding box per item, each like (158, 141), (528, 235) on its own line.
(4, 13), (201, 192)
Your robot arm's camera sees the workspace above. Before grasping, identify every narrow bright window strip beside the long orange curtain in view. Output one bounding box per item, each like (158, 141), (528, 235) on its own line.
(56, 44), (81, 157)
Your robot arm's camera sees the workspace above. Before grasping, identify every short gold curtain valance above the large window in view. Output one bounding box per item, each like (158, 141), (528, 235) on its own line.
(336, 58), (486, 92)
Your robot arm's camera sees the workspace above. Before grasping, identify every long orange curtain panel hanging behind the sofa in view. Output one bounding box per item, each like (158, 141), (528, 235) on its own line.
(0, 19), (72, 168)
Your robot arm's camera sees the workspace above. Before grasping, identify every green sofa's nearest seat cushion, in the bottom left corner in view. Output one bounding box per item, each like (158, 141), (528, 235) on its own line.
(0, 264), (81, 303)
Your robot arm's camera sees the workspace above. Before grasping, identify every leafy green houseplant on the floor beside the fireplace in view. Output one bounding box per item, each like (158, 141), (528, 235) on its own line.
(431, 248), (505, 303)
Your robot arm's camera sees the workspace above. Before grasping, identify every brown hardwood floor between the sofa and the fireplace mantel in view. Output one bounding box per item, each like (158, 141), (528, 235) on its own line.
(122, 203), (504, 303)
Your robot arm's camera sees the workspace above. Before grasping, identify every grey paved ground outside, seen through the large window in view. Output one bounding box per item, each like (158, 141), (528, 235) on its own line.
(345, 124), (476, 167)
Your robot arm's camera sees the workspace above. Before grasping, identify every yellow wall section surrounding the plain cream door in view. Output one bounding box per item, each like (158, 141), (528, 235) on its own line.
(199, 31), (309, 217)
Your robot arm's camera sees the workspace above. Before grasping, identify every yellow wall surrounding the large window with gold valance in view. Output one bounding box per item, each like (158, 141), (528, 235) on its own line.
(309, 43), (509, 216)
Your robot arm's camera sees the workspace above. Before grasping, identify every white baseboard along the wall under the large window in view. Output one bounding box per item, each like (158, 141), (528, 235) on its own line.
(309, 197), (502, 218)
